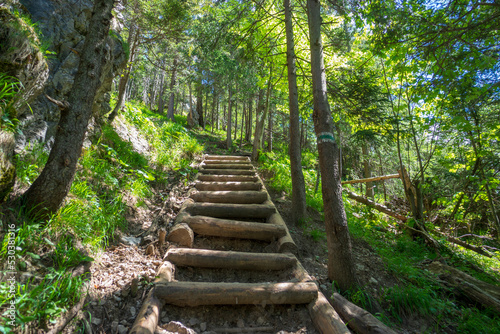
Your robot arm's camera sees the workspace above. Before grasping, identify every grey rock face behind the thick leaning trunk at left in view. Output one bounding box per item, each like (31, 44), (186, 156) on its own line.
(17, 0), (126, 148)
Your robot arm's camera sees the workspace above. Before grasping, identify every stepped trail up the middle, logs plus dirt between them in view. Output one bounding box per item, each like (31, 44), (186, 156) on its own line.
(125, 156), (347, 334)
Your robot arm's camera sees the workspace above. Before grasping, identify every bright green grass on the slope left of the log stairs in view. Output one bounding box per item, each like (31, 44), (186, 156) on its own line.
(0, 96), (204, 332)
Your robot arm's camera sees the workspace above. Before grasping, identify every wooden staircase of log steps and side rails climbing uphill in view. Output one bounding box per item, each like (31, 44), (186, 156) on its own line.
(130, 155), (349, 334)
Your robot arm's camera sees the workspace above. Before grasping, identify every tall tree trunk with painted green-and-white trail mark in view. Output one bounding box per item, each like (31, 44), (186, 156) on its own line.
(307, 0), (358, 290)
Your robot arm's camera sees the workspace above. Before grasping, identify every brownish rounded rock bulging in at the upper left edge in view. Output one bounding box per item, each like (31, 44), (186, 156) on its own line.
(0, 0), (49, 202)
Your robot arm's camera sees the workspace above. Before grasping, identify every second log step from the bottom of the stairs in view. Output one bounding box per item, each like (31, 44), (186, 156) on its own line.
(165, 248), (297, 270)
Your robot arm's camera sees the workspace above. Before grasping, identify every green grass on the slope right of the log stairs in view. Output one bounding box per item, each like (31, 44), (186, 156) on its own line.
(259, 148), (500, 333)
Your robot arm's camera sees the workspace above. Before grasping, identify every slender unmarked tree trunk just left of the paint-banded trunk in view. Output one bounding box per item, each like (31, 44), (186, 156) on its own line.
(283, 0), (306, 224)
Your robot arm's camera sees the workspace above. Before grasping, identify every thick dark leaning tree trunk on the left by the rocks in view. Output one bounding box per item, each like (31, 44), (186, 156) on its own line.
(23, 0), (114, 218)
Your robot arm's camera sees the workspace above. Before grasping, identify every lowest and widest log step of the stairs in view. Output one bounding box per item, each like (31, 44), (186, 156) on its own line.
(155, 282), (318, 307)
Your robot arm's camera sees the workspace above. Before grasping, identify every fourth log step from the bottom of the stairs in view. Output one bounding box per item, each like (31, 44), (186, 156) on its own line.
(186, 203), (276, 218)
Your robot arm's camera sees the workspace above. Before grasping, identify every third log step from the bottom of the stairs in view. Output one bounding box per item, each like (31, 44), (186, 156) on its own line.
(182, 216), (287, 241)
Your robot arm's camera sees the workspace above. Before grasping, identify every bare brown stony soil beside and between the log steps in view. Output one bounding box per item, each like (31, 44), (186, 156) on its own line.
(47, 128), (496, 334)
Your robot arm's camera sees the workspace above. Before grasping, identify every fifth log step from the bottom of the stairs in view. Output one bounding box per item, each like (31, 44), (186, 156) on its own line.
(190, 191), (267, 204)
